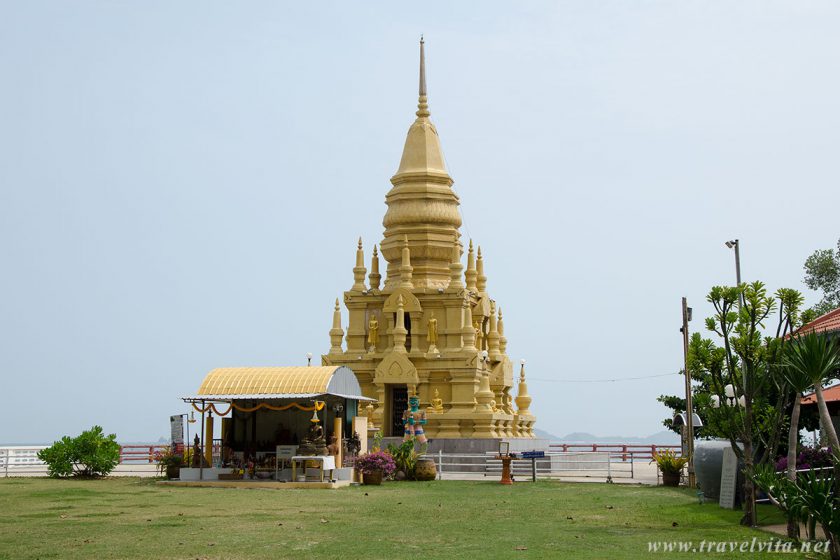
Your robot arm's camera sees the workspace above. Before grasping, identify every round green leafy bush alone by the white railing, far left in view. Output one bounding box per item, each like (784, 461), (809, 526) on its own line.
(38, 426), (120, 478)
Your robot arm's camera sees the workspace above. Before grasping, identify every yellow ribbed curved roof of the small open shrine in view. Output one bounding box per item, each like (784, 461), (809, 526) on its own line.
(191, 366), (367, 400)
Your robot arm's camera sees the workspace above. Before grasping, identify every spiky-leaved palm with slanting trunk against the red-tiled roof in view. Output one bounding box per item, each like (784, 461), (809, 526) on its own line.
(783, 332), (840, 452)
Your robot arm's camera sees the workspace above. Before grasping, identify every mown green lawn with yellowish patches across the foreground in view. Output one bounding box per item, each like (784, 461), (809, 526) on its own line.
(0, 478), (820, 560)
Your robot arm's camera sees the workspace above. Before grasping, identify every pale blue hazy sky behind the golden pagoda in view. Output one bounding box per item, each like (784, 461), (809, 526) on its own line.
(0, 0), (840, 443)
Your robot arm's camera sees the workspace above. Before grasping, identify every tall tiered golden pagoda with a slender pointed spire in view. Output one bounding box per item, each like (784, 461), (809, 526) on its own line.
(322, 39), (536, 438)
